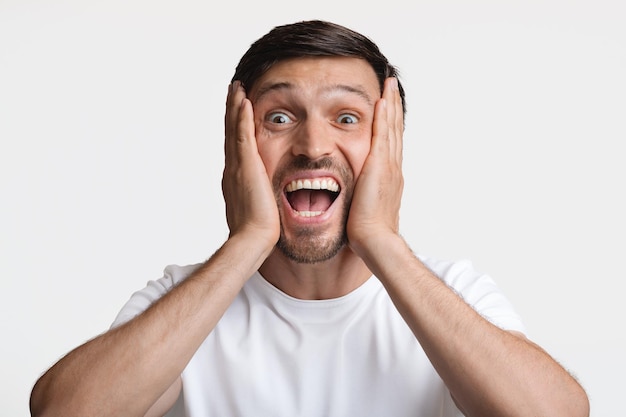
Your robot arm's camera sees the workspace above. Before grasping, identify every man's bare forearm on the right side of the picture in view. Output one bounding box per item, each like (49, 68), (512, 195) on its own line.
(361, 236), (589, 417)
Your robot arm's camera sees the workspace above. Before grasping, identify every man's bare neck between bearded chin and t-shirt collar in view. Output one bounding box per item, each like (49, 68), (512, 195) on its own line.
(259, 246), (372, 300)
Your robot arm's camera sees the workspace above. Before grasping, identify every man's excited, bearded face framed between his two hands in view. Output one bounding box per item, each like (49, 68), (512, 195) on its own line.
(248, 57), (381, 263)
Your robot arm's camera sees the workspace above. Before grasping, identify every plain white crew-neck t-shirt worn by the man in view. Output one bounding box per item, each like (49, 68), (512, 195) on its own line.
(113, 258), (524, 417)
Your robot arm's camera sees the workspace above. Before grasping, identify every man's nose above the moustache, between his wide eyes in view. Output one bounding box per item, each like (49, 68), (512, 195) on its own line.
(292, 117), (334, 160)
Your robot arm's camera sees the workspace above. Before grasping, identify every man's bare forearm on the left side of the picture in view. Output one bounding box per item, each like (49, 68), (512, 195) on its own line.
(31, 234), (268, 417)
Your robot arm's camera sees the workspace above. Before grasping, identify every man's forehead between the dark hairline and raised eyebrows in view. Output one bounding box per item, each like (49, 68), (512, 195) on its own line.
(248, 57), (381, 103)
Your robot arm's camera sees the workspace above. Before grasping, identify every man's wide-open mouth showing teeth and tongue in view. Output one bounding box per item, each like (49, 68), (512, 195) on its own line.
(285, 178), (340, 217)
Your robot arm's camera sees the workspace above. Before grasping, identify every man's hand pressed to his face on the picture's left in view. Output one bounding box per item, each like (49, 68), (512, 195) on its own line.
(222, 81), (280, 250)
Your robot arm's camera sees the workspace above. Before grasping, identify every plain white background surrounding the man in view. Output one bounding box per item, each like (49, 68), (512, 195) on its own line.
(0, 0), (626, 417)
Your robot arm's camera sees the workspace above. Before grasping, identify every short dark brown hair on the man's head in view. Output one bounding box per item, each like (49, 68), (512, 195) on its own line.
(232, 20), (406, 113)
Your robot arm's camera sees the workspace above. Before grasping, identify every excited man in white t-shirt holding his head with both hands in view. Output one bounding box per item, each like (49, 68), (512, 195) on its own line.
(31, 21), (589, 417)
